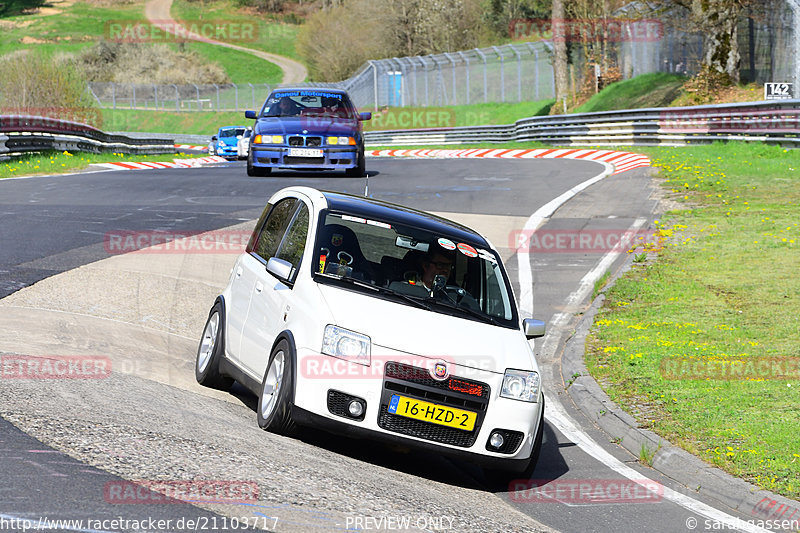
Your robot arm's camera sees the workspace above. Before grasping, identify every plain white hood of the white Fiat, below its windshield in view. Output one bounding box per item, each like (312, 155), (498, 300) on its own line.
(317, 284), (537, 373)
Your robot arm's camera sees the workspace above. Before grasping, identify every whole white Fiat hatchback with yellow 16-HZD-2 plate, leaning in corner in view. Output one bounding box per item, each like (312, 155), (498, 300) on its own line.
(195, 187), (544, 472)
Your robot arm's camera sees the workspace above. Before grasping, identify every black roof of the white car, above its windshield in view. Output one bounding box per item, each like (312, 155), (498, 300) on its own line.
(320, 191), (490, 248)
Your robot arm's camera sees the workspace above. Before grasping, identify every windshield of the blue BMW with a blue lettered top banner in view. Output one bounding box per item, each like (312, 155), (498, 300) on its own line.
(261, 90), (356, 119)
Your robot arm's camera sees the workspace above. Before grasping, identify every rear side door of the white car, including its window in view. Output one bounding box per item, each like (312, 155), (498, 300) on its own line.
(225, 197), (297, 366)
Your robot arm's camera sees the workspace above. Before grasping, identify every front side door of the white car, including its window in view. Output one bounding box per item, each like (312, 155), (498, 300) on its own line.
(241, 196), (309, 379)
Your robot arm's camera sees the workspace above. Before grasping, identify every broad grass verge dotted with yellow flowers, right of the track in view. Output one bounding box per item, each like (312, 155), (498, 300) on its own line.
(586, 143), (800, 499)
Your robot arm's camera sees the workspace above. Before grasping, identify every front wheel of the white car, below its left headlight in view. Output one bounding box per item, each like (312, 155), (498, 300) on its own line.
(256, 339), (295, 435)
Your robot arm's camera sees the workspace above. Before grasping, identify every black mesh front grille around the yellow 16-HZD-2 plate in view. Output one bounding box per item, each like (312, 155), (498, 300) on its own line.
(378, 361), (491, 447)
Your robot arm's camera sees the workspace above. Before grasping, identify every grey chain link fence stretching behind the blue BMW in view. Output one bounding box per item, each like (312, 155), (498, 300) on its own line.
(89, 42), (555, 112)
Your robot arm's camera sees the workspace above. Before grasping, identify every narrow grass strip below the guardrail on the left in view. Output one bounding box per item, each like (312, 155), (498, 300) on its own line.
(0, 152), (202, 179)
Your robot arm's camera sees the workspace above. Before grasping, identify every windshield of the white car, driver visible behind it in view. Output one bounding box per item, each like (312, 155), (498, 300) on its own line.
(313, 212), (518, 328)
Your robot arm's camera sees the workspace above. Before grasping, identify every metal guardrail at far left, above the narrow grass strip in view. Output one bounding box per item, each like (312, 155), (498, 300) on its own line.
(0, 115), (175, 160)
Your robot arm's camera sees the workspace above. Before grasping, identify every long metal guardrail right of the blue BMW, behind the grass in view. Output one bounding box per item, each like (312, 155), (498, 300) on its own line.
(365, 100), (800, 147)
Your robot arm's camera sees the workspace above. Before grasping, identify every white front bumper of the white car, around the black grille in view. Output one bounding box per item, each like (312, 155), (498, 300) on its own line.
(294, 350), (543, 466)
